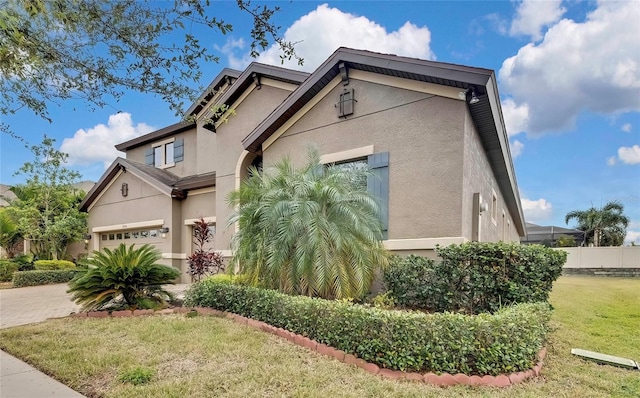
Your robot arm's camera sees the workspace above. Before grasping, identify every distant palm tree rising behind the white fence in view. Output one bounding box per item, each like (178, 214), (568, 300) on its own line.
(565, 201), (629, 247)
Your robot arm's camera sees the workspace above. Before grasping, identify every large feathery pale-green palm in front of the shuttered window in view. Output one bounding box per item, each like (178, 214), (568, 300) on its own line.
(228, 151), (388, 298)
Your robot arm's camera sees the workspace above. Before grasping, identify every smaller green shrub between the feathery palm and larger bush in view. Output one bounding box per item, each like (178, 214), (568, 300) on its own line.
(383, 255), (438, 309)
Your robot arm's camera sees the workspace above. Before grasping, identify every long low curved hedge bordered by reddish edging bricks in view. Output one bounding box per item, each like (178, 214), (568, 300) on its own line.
(185, 280), (551, 375)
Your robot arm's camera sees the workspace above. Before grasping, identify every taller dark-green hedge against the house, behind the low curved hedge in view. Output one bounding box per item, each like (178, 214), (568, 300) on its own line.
(384, 242), (567, 314)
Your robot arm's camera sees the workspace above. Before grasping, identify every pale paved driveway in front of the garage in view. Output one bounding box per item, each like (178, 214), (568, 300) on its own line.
(0, 283), (80, 328)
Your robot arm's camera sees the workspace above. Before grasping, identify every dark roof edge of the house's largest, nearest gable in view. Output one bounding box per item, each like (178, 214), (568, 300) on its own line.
(242, 47), (525, 236)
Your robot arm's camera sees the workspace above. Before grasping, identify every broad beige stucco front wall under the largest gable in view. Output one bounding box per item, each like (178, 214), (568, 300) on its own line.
(263, 79), (466, 239)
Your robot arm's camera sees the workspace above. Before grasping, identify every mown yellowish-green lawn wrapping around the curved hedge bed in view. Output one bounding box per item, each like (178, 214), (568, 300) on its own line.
(0, 277), (640, 397)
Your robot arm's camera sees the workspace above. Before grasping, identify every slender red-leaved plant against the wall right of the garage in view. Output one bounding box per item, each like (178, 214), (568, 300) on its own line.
(187, 217), (224, 282)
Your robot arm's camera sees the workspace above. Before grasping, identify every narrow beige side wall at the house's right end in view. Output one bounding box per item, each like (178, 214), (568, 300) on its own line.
(462, 109), (520, 242)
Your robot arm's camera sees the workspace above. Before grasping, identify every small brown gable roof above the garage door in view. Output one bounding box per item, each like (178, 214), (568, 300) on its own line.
(80, 158), (216, 212)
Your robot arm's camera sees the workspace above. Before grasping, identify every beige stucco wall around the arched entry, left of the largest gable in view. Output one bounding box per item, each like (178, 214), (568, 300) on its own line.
(215, 85), (290, 250)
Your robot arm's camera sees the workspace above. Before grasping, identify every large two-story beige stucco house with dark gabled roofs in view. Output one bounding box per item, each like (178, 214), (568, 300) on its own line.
(81, 48), (525, 281)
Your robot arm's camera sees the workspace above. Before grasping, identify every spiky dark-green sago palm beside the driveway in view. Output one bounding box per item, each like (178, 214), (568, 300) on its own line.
(67, 244), (180, 311)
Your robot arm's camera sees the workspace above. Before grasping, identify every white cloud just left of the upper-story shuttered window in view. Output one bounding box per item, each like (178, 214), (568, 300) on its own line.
(60, 113), (154, 167)
